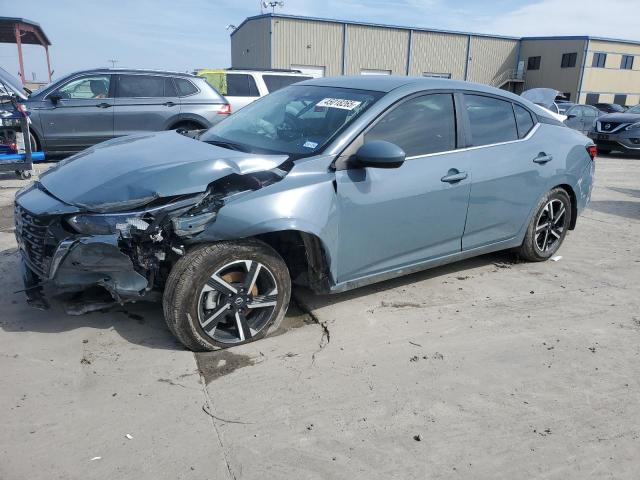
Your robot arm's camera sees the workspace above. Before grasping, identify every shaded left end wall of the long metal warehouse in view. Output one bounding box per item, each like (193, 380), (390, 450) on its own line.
(230, 18), (271, 68)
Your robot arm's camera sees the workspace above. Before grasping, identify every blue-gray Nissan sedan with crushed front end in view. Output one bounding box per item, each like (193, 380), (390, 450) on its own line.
(15, 77), (596, 350)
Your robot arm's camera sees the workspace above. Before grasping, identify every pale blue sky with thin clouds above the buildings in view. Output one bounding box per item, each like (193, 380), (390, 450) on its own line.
(0, 0), (640, 79)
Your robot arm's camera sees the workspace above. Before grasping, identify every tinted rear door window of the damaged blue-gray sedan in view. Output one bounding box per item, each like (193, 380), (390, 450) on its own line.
(465, 95), (520, 147)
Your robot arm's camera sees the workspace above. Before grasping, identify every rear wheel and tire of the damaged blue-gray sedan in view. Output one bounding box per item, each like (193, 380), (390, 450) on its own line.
(519, 188), (571, 262)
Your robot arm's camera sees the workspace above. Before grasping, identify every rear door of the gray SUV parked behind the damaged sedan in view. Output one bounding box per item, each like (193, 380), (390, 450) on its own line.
(114, 74), (180, 136)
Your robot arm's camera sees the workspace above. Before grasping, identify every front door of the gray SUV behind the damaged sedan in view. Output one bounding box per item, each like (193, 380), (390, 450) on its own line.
(39, 74), (114, 151)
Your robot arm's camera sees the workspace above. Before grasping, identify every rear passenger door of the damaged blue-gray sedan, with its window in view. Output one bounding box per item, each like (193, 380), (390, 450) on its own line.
(462, 93), (553, 250)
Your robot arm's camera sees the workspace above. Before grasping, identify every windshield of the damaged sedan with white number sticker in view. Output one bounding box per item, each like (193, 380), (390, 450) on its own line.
(200, 85), (383, 156)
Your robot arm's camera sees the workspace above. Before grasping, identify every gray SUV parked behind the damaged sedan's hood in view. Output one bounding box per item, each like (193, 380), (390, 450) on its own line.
(25, 69), (230, 153)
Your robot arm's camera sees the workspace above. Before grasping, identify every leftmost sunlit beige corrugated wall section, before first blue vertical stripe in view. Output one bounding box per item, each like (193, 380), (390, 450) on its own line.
(272, 17), (343, 75)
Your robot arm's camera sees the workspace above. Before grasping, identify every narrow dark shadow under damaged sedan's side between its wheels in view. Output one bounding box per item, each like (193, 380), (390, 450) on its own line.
(293, 250), (524, 309)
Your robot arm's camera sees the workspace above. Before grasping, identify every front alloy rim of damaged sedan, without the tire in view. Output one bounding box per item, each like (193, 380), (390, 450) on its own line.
(198, 260), (278, 344)
